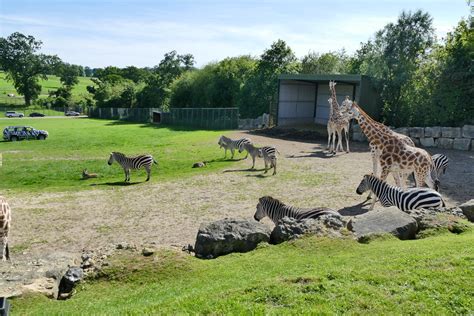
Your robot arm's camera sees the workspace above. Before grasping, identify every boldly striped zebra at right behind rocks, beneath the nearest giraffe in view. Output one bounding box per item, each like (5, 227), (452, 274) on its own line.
(356, 175), (446, 212)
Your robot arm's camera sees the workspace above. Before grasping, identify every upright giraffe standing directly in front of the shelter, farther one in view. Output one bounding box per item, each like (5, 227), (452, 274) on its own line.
(327, 81), (352, 153)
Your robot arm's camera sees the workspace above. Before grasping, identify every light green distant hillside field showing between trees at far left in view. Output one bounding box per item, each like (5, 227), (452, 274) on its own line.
(0, 72), (93, 105)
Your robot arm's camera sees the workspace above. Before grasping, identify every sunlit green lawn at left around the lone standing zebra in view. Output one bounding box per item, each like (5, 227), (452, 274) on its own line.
(0, 118), (237, 192)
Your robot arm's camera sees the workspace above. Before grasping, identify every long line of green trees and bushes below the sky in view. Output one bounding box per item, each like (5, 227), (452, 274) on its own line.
(0, 10), (474, 126)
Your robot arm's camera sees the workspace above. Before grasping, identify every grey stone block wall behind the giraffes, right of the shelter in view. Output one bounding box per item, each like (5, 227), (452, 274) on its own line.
(352, 124), (474, 151)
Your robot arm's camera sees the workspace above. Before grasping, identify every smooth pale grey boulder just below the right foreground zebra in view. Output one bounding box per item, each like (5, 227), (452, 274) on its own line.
(347, 206), (417, 240)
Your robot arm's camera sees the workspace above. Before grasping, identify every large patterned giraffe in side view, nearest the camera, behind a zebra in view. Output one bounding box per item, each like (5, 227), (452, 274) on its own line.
(352, 102), (439, 209)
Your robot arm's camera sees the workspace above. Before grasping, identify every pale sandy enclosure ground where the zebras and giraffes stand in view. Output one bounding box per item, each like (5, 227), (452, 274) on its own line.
(7, 132), (474, 259)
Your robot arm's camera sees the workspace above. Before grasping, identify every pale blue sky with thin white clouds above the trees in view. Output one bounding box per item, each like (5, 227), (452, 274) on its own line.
(0, 0), (469, 67)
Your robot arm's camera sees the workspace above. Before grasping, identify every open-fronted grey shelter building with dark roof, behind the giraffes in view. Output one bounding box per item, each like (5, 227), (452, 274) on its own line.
(276, 74), (379, 127)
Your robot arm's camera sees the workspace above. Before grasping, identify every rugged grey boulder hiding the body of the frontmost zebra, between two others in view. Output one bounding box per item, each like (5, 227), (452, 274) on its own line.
(270, 214), (346, 244)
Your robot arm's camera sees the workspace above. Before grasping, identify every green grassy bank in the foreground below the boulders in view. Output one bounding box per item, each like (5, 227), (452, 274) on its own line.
(12, 230), (474, 315)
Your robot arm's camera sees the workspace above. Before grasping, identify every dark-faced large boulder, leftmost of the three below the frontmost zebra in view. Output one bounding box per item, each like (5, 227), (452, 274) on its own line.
(194, 218), (271, 259)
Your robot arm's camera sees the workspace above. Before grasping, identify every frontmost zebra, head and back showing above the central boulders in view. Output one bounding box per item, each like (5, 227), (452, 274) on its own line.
(253, 196), (341, 225)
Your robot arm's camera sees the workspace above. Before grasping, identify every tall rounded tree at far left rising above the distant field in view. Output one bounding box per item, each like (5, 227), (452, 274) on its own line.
(0, 32), (51, 106)
